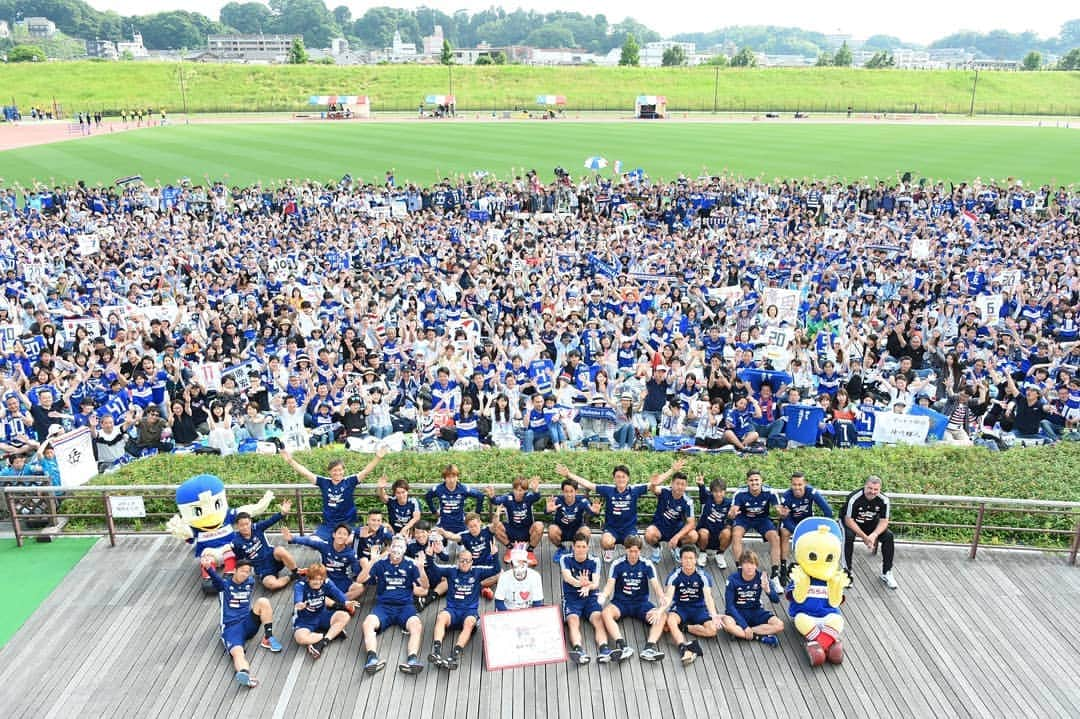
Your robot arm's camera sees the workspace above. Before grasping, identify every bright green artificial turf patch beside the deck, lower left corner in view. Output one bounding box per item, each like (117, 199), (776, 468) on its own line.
(0, 538), (97, 648)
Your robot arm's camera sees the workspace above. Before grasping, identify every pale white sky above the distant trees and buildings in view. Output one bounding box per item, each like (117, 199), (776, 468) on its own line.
(82, 0), (1080, 44)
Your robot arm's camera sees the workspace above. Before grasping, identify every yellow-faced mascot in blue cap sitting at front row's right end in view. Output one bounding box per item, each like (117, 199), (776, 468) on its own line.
(786, 517), (848, 666)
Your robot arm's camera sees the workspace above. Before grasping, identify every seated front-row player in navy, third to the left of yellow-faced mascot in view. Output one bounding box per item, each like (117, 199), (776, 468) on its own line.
(598, 537), (664, 662)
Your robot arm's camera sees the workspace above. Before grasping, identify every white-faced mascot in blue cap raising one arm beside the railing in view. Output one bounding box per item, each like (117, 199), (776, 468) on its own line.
(165, 474), (273, 594)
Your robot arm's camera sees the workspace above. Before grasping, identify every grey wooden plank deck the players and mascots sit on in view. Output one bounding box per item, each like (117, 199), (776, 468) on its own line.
(0, 537), (1080, 719)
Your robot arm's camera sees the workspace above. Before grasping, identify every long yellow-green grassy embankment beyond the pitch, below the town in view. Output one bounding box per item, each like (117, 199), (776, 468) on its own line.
(0, 62), (1080, 116)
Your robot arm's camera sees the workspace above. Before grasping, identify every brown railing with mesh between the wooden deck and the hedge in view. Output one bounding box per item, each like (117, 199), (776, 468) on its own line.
(0, 484), (1080, 566)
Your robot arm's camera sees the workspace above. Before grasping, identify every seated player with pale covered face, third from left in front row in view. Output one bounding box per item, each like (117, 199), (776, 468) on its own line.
(359, 537), (428, 674)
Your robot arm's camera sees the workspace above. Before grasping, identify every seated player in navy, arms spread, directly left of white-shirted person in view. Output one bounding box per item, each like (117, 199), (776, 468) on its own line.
(417, 552), (499, 669)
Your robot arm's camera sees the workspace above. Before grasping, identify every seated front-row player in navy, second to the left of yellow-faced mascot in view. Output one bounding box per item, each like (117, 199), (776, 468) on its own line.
(642, 546), (719, 664)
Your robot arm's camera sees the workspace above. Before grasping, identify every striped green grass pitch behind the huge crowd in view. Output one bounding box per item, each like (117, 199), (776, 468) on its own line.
(0, 120), (1080, 186)
